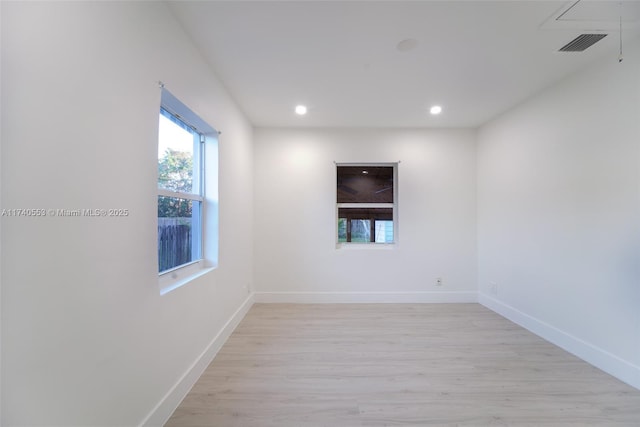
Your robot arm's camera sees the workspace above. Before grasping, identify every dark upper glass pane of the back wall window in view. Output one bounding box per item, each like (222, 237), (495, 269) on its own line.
(337, 165), (393, 203)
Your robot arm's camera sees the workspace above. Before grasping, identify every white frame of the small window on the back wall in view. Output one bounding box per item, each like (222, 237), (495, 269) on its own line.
(334, 162), (400, 249)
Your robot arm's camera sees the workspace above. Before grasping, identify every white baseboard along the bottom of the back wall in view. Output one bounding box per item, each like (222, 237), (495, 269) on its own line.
(255, 291), (478, 304)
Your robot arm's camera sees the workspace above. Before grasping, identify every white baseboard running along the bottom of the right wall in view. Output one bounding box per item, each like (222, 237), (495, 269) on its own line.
(478, 293), (640, 389)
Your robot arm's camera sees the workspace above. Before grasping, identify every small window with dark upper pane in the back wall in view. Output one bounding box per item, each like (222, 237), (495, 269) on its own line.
(336, 164), (397, 243)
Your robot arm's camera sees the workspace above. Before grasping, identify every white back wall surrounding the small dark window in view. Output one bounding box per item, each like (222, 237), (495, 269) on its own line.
(254, 129), (476, 302)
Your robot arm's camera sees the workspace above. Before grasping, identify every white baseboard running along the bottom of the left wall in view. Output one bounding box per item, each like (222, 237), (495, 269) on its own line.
(140, 294), (254, 427)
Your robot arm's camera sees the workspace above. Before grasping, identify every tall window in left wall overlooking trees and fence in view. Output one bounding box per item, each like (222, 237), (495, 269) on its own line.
(158, 90), (217, 290)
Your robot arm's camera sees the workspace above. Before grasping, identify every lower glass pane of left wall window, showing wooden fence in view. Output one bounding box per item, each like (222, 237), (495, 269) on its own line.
(158, 196), (202, 273)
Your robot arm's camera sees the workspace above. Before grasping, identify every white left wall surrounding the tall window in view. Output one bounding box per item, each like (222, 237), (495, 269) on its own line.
(1, 2), (253, 426)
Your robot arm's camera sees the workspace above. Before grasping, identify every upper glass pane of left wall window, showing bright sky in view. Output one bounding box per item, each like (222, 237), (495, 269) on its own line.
(158, 110), (200, 194)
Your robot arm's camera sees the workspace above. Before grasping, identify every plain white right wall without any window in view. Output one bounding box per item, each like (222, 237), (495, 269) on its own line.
(478, 44), (640, 387)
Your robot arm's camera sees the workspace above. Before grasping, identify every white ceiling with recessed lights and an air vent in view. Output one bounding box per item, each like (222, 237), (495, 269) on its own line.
(170, 0), (640, 128)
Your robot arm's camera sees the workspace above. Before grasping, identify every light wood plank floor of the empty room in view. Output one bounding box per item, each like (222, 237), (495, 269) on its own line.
(167, 304), (640, 427)
